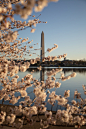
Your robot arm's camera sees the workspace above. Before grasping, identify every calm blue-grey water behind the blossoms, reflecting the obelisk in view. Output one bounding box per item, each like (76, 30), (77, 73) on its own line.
(0, 67), (86, 110)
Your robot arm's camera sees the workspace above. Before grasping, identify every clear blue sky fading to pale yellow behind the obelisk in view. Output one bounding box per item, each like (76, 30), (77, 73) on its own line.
(15, 0), (86, 60)
